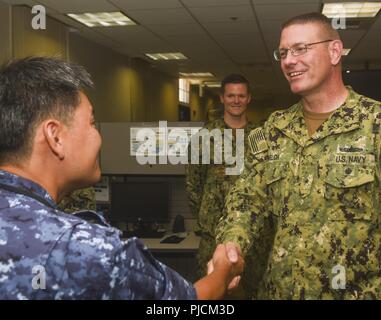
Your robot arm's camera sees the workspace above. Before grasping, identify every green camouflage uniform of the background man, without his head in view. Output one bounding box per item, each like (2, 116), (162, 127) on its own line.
(186, 119), (273, 299)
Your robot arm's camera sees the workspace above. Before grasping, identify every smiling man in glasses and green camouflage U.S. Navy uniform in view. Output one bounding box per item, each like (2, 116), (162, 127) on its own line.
(214, 13), (381, 299)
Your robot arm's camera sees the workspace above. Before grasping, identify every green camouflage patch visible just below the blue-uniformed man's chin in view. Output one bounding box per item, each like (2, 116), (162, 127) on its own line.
(58, 187), (96, 213)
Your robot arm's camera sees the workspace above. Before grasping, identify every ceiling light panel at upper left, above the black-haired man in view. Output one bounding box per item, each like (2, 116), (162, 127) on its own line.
(67, 12), (136, 27)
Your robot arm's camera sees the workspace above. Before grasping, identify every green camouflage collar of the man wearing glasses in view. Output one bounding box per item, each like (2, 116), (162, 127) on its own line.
(274, 86), (360, 146)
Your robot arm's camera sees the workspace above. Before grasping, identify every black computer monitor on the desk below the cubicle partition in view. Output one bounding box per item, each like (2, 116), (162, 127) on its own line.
(110, 181), (170, 223)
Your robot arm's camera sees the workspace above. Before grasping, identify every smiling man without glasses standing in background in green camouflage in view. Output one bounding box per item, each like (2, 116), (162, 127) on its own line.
(186, 74), (272, 298)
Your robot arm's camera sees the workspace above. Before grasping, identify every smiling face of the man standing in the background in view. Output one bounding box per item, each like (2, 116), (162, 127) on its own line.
(220, 83), (251, 117)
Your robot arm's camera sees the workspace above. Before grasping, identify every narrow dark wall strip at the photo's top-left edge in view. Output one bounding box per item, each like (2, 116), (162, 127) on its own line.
(0, 2), (12, 64)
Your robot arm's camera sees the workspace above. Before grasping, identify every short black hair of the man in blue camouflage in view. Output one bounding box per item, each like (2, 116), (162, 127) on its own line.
(0, 57), (93, 164)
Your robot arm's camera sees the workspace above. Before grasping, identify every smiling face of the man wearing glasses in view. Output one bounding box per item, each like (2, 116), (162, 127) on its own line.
(279, 23), (332, 96)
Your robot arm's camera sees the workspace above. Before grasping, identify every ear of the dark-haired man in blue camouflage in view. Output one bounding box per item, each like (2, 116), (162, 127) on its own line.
(42, 119), (66, 160)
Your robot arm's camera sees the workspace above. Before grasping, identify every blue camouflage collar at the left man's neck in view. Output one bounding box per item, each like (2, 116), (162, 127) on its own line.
(0, 170), (57, 208)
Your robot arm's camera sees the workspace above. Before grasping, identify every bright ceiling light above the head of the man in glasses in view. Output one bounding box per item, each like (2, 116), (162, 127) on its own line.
(322, 2), (381, 18)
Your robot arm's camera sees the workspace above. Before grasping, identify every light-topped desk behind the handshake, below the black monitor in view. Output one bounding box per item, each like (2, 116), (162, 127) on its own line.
(140, 232), (200, 282)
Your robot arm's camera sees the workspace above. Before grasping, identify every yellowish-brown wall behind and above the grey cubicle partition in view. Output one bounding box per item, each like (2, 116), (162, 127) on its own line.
(69, 33), (178, 122)
